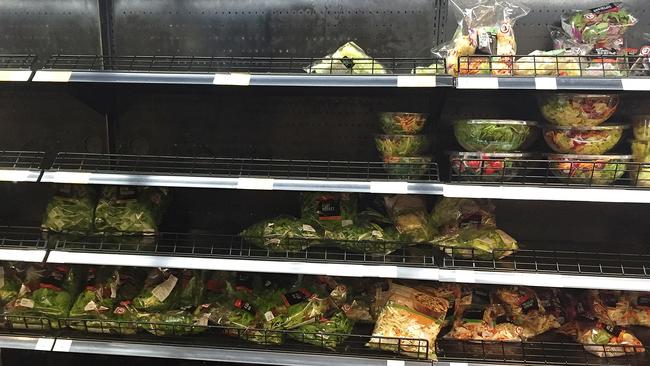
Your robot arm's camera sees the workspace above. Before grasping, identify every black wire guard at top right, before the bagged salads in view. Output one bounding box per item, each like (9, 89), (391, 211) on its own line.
(456, 55), (650, 78)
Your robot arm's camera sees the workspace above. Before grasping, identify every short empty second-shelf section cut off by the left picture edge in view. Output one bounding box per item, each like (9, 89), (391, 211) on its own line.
(0, 151), (44, 182)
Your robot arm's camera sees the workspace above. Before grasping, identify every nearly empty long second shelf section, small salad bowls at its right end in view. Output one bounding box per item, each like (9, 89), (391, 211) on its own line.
(41, 153), (442, 194)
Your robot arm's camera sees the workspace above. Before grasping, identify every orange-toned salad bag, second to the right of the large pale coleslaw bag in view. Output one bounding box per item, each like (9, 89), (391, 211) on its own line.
(495, 286), (562, 335)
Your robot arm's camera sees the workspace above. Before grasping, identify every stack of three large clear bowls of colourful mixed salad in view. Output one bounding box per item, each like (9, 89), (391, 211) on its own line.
(539, 93), (632, 185)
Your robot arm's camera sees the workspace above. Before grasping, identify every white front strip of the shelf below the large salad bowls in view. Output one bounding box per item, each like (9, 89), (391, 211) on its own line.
(442, 184), (650, 203)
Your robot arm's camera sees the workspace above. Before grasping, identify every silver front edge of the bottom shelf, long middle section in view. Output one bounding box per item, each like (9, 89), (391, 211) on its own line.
(53, 339), (436, 366)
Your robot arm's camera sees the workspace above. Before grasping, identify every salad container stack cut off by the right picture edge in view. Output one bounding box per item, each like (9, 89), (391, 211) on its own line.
(630, 115), (650, 187)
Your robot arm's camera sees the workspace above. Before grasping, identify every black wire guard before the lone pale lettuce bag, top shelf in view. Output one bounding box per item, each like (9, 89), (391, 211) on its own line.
(43, 55), (445, 75)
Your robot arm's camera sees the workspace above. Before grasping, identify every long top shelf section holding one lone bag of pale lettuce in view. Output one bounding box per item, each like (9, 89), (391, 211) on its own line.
(34, 55), (454, 87)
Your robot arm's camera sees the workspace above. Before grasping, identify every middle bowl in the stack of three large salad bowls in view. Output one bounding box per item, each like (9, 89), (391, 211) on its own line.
(544, 125), (628, 155)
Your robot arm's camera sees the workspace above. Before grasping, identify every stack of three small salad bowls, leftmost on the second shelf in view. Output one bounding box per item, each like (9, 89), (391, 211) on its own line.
(375, 112), (431, 180)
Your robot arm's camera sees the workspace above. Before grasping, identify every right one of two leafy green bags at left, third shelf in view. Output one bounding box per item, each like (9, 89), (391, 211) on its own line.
(95, 186), (169, 234)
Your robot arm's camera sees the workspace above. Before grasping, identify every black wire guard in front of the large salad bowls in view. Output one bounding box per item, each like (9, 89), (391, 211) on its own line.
(449, 154), (650, 189)
